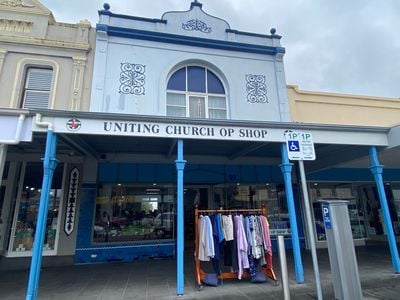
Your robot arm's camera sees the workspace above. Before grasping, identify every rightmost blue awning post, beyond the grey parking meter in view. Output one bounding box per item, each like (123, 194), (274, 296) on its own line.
(369, 147), (400, 273)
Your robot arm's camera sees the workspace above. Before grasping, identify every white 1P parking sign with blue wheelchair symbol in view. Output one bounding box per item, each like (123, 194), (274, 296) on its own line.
(285, 131), (315, 160)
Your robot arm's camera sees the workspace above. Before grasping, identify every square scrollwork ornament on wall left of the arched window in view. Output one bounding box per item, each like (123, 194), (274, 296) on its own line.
(119, 63), (146, 95)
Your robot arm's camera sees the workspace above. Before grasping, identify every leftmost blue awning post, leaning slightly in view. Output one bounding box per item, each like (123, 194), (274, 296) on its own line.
(26, 130), (58, 300)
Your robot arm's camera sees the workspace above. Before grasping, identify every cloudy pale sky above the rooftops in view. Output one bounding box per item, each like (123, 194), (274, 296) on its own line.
(40, 0), (400, 98)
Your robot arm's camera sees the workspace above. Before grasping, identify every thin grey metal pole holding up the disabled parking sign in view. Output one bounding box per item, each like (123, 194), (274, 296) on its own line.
(299, 160), (322, 300)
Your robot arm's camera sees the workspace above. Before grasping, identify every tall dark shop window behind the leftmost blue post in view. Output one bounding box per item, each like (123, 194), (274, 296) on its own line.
(10, 162), (63, 253)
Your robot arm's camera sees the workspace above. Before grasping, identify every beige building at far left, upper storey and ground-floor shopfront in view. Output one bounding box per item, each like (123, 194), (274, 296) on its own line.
(0, 0), (95, 269)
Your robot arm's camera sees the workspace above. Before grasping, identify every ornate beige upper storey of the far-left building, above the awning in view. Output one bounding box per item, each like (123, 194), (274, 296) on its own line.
(0, 0), (94, 111)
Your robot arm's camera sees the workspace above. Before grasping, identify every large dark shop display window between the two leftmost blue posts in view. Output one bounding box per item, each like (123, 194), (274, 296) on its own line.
(93, 184), (176, 243)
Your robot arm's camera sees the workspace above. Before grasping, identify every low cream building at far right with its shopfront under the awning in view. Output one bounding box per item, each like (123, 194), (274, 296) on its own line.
(288, 86), (400, 247)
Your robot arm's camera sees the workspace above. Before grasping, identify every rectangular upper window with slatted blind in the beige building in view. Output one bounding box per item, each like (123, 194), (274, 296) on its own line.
(22, 68), (53, 108)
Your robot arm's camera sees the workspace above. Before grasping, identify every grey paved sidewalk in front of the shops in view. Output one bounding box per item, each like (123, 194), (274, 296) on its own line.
(0, 246), (400, 300)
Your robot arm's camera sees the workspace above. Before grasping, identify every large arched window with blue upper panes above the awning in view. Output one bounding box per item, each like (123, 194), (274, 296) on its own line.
(167, 66), (227, 119)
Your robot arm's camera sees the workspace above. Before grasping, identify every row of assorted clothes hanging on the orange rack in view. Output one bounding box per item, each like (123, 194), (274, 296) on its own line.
(198, 213), (272, 279)
